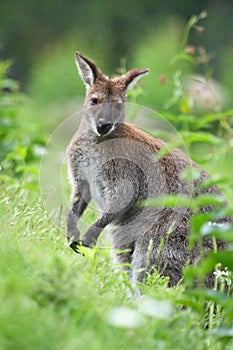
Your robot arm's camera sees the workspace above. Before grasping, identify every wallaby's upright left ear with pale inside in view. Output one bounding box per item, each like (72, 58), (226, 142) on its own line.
(76, 52), (100, 88)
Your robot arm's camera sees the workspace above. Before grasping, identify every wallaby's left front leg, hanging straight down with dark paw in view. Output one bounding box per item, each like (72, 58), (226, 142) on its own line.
(67, 182), (91, 251)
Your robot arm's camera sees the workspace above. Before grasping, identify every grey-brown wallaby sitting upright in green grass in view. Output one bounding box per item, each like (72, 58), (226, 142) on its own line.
(67, 53), (228, 286)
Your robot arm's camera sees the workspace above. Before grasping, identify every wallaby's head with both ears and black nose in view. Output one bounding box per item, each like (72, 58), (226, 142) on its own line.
(76, 52), (149, 137)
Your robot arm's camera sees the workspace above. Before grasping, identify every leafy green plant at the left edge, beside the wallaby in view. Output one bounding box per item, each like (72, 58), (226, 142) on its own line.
(0, 61), (44, 188)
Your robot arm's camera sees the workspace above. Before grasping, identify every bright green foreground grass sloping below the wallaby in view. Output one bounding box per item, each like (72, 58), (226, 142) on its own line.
(0, 187), (232, 350)
